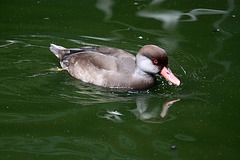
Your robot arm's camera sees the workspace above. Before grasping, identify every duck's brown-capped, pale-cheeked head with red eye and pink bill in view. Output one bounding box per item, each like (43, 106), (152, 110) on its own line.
(136, 45), (180, 86)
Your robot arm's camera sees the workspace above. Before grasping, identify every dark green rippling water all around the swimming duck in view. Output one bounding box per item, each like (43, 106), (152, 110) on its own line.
(0, 0), (240, 160)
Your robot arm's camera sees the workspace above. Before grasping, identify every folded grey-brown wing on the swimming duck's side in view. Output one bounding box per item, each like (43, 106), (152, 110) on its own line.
(65, 48), (135, 74)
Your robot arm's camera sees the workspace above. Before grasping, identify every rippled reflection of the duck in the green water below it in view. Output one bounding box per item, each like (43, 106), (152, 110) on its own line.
(62, 80), (180, 123)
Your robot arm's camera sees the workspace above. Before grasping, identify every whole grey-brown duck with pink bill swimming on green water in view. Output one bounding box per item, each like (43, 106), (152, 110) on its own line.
(50, 44), (180, 90)
